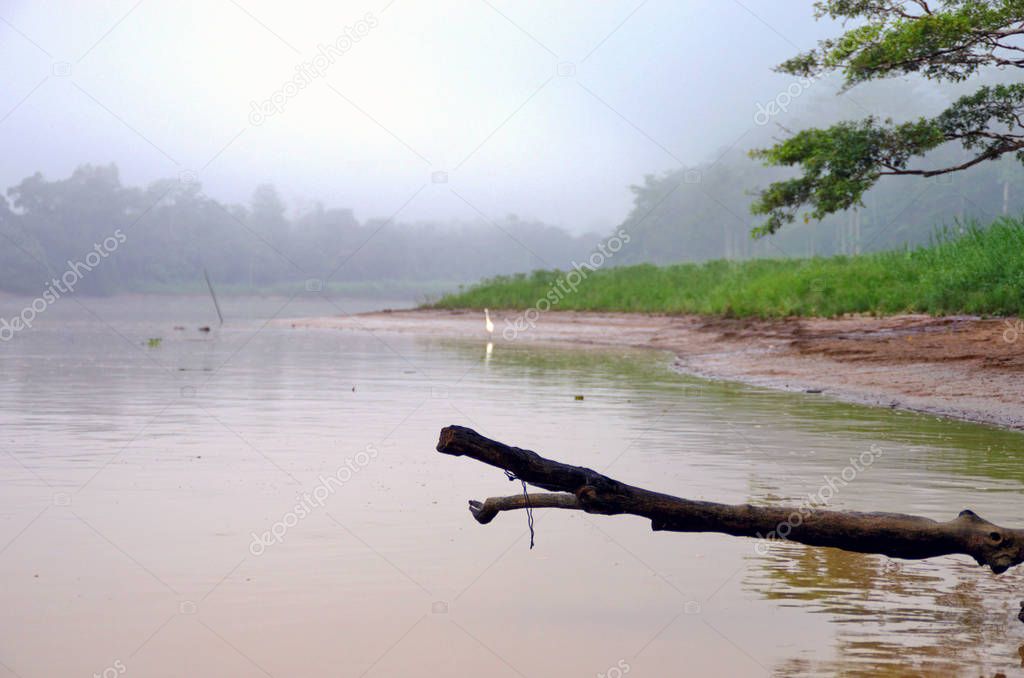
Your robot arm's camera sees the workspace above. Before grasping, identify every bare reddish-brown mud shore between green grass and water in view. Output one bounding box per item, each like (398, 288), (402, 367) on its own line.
(287, 309), (1024, 429)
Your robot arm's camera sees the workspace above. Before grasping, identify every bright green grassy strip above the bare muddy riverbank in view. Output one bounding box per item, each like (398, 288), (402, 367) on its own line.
(435, 219), (1024, 317)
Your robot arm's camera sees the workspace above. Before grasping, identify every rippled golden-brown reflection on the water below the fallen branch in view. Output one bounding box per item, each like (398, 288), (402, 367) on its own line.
(743, 547), (1022, 676)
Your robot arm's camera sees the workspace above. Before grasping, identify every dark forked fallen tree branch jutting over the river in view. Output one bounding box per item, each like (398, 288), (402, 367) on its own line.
(437, 426), (1024, 575)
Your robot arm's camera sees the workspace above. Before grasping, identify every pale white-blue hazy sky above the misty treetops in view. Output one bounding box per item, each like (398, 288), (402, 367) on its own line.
(0, 0), (837, 232)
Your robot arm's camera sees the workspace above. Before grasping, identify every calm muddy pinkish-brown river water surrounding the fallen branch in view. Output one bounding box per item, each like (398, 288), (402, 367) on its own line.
(0, 295), (1024, 677)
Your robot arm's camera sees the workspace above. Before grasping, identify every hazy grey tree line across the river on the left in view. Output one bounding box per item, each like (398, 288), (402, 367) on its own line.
(0, 165), (598, 294)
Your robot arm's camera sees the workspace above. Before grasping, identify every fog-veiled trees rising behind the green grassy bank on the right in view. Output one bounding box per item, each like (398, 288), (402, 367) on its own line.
(615, 75), (1024, 264)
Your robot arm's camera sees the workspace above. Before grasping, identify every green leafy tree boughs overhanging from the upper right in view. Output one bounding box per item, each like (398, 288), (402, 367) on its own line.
(751, 0), (1024, 236)
